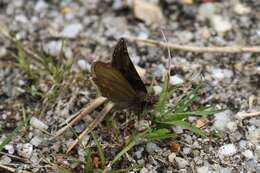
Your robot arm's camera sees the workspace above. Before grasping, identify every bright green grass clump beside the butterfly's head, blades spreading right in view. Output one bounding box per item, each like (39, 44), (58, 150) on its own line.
(107, 74), (221, 170)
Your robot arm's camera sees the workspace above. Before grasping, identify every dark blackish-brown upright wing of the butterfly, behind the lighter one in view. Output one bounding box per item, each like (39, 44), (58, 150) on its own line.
(112, 38), (147, 95)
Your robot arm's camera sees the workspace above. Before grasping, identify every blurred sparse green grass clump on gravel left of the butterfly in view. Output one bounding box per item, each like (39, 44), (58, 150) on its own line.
(16, 41), (74, 103)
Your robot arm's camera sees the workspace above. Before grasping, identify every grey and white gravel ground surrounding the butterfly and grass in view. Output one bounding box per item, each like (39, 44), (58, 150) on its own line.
(0, 0), (260, 173)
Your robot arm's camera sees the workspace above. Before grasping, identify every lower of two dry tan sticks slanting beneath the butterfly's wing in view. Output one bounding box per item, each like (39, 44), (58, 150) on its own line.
(66, 102), (114, 154)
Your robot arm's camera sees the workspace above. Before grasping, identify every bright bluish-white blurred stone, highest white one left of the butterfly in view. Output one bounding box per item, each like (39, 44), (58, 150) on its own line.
(61, 23), (83, 38)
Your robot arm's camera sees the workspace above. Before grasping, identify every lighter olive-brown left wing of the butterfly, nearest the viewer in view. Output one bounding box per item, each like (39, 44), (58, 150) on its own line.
(91, 62), (138, 108)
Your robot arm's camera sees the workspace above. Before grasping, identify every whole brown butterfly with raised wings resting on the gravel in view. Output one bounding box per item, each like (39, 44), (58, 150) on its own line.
(91, 38), (155, 111)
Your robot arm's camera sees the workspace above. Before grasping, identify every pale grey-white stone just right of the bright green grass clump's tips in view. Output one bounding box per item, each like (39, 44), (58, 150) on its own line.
(213, 110), (232, 131)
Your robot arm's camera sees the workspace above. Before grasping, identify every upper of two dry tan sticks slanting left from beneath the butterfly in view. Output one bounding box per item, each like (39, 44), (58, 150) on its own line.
(53, 97), (107, 138)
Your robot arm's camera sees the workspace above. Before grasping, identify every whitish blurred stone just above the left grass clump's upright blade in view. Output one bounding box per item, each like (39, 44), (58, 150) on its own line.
(43, 41), (62, 56)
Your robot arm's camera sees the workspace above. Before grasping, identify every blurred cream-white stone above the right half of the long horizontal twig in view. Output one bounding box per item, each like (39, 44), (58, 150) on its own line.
(210, 15), (232, 33)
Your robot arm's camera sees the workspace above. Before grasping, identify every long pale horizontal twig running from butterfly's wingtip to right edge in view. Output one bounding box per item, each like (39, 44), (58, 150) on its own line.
(126, 37), (260, 53)
